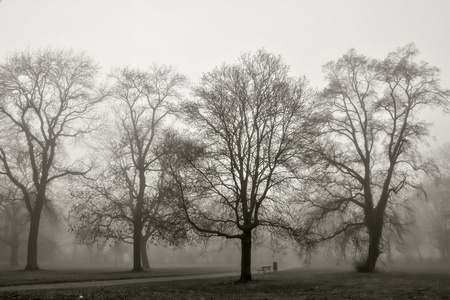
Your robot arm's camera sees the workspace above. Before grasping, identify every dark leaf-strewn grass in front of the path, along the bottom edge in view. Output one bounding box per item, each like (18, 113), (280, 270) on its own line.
(0, 268), (450, 299)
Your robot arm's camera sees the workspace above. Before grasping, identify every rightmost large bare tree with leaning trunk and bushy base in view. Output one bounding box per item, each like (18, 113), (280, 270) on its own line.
(306, 44), (450, 272)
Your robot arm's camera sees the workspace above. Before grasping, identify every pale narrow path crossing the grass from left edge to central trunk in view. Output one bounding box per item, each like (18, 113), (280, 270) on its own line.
(0, 272), (240, 292)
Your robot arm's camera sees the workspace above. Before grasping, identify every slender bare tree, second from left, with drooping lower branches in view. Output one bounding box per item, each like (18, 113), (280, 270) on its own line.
(68, 65), (186, 271)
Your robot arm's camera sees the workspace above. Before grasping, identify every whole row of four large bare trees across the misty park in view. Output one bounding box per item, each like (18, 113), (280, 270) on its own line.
(0, 44), (450, 281)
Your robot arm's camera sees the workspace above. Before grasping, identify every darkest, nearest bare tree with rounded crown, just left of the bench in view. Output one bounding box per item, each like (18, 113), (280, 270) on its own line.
(167, 50), (313, 281)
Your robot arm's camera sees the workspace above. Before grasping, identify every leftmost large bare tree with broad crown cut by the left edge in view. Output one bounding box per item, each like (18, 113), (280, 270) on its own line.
(0, 49), (104, 270)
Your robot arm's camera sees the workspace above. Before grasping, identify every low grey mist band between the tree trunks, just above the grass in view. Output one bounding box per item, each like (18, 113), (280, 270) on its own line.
(0, 146), (450, 272)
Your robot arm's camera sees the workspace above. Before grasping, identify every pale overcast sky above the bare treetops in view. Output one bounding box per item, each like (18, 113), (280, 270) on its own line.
(0, 0), (450, 143)
